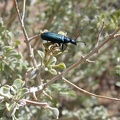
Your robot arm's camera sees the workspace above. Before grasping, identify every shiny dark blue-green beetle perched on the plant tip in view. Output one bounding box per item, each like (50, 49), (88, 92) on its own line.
(41, 32), (85, 51)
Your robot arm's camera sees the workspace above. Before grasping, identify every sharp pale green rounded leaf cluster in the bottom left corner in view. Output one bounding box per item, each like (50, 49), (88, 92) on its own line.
(0, 79), (28, 119)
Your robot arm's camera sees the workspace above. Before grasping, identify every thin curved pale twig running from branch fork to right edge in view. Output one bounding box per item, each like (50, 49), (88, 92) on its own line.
(62, 77), (120, 101)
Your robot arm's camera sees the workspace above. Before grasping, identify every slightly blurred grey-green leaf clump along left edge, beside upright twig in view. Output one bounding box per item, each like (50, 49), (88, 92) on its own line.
(0, 18), (28, 84)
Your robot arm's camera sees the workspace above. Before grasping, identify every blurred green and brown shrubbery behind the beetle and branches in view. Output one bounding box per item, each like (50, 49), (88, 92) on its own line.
(0, 0), (120, 120)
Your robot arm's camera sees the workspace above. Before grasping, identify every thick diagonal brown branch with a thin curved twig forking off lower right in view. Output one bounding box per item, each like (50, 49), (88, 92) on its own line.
(44, 27), (120, 101)
